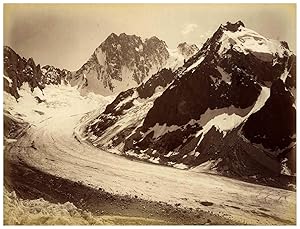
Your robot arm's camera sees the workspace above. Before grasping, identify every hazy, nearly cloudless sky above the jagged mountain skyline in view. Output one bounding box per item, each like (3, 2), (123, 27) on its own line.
(3, 3), (296, 71)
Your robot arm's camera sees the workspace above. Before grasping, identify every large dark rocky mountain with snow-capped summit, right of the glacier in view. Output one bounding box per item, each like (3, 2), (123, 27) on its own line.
(85, 21), (296, 188)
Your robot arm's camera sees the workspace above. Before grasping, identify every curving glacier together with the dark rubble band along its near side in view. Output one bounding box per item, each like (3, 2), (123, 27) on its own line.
(4, 87), (296, 225)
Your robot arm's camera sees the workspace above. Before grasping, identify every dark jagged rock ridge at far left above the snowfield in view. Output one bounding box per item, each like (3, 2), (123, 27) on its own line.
(4, 46), (71, 99)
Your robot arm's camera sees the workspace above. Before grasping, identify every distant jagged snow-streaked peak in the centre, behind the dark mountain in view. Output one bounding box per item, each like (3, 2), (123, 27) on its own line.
(70, 33), (169, 95)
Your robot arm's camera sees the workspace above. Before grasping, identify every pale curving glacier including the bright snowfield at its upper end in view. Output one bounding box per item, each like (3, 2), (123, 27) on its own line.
(5, 86), (296, 225)
